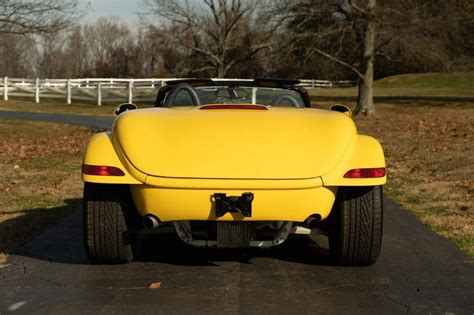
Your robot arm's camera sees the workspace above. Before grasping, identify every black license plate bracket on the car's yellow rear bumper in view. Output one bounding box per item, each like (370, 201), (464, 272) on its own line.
(213, 192), (253, 218)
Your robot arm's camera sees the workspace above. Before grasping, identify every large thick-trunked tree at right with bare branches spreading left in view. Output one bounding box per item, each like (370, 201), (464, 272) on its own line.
(276, 0), (386, 115)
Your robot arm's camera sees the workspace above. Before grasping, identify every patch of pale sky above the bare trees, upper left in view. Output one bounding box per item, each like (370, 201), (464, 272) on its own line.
(80, 0), (140, 26)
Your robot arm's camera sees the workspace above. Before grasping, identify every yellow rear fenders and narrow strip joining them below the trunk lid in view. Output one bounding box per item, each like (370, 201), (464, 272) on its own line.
(82, 114), (387, 189)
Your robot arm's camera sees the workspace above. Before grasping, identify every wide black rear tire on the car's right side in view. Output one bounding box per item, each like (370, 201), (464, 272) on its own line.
(328, 186), (383, 266)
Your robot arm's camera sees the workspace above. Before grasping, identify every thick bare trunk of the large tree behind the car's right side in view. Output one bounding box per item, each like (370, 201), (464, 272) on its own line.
(357, 0), (377, 115)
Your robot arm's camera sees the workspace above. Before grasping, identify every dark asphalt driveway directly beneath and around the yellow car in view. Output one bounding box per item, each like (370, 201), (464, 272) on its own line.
(0, 110), (474, 314)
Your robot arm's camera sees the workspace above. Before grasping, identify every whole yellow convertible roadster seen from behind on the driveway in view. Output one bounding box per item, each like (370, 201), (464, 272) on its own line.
(82, 79), (386, 265)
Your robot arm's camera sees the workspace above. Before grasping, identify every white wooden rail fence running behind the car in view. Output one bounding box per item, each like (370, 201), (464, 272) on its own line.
(0, 77), (354, 106)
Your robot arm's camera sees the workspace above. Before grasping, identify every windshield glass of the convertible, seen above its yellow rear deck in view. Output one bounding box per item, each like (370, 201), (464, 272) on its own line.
(170, 86), (305, 107)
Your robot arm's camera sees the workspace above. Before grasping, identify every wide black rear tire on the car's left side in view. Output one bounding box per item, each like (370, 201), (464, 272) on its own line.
(83, 183), (134, 264)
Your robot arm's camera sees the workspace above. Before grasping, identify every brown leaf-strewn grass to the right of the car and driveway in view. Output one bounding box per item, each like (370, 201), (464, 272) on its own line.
(356, 104), (474, 257)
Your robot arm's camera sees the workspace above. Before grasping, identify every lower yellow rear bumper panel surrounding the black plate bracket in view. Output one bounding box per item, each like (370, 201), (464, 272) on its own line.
(130, 185), (337, 222)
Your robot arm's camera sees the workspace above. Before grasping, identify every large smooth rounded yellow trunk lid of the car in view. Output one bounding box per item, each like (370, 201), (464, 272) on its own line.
(113, 107), (356, 179)
